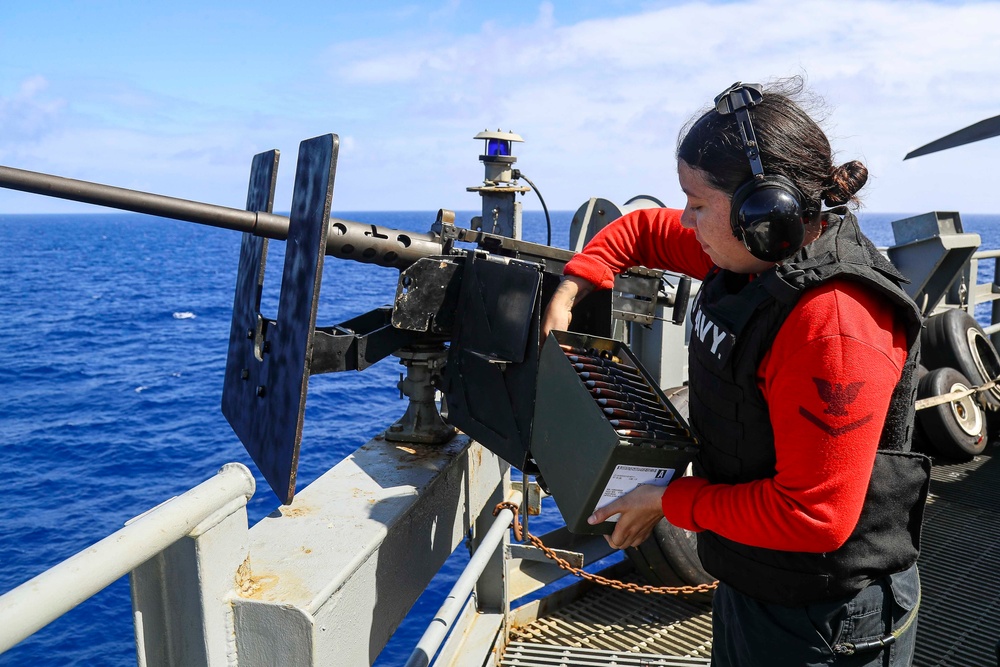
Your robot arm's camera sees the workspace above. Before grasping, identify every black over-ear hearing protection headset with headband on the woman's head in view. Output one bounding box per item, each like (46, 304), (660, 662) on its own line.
(715, 81), (806, 262)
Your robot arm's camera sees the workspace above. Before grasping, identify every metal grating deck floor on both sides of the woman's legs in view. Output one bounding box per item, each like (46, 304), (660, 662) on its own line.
(501, 442), (1000, 667)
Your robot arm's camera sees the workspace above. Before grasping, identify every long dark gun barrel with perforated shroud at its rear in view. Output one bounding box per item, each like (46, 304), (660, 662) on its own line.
(0, 165), (444, 269)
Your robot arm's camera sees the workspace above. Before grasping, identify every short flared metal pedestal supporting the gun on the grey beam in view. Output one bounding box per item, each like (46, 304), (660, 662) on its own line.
(385, 343), (455, 445)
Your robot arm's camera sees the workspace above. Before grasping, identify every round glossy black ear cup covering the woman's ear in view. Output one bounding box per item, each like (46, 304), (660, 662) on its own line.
(729, 176), (806, 262)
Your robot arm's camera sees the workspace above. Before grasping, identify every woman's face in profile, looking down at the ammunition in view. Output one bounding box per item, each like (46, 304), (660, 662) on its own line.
(677, 160), (774, 273)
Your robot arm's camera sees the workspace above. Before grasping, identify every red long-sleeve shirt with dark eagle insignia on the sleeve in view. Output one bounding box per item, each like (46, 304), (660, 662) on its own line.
(565, 209), (906, 553)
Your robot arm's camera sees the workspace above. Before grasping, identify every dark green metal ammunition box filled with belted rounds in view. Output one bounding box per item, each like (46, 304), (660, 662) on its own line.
(531, 331), (698, 534)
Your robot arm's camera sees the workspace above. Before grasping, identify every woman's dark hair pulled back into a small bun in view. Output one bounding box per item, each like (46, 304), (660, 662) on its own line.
(677, 77), (868, 212)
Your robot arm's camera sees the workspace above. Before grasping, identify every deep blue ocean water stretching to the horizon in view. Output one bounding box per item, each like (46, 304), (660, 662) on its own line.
(0, 209), (1000, 665)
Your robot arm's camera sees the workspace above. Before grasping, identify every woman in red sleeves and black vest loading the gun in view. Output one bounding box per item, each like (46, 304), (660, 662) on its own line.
(543, 79), (930, 667)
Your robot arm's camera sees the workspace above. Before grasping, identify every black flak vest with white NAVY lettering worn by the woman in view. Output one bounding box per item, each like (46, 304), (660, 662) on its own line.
(689, 209), (930, 606)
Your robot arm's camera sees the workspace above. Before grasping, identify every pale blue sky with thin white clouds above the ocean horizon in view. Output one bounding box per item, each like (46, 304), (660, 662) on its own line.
(0, 0), (1000, 213)
